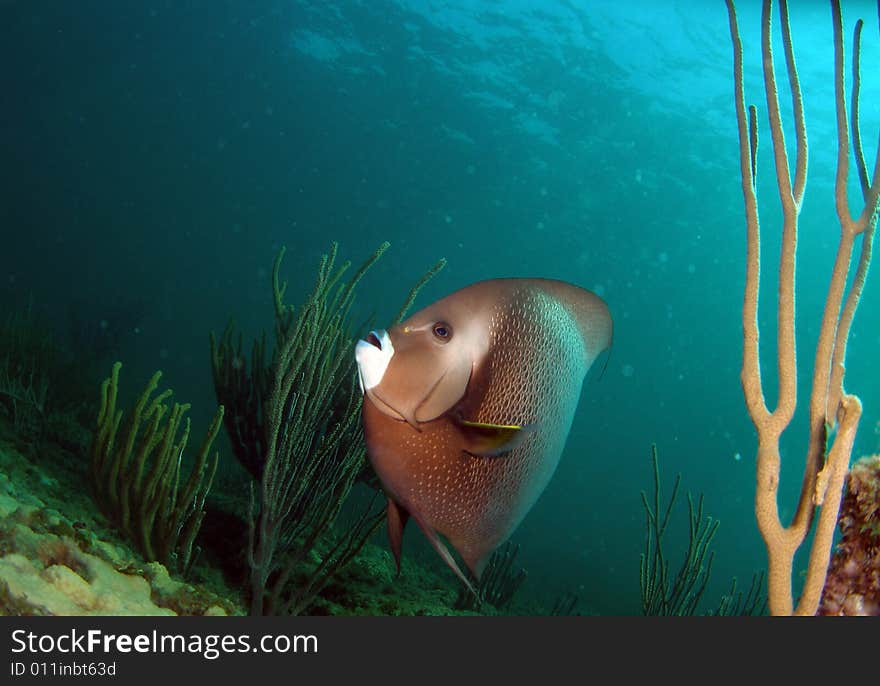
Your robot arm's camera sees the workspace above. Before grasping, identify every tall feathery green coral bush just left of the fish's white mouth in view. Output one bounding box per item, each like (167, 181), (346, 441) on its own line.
(248, 243), (388, 614)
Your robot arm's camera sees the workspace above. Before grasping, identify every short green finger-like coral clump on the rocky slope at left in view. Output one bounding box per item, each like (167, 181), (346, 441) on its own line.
(91, 362), (223, 574)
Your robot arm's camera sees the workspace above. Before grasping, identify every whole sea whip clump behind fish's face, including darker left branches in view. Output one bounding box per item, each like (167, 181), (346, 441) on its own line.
(211, 243), (445, 614)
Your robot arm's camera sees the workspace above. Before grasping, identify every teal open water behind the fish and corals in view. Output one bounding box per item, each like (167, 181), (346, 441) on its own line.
(0, 0), (880, 614)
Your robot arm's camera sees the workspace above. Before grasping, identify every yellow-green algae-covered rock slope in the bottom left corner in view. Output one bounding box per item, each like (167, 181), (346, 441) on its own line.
(0, 430), (242, 616)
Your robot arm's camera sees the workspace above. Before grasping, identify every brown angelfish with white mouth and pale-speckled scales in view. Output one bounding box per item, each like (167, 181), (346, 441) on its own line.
(358, 279), (611, 583)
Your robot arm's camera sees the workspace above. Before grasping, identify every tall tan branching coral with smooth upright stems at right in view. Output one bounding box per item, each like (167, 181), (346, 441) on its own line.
(727, 0), (880, 615)
